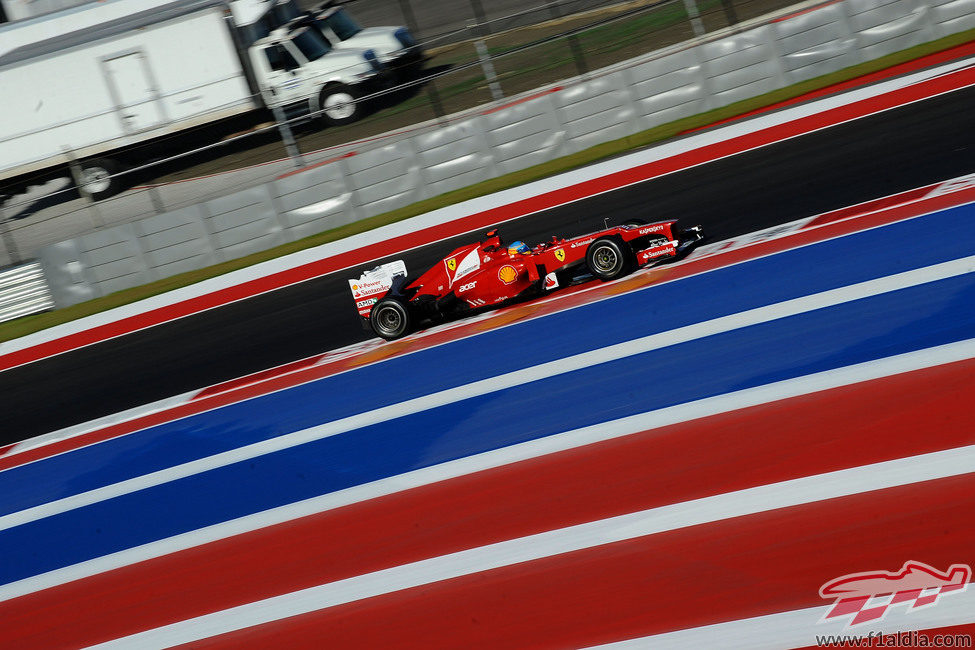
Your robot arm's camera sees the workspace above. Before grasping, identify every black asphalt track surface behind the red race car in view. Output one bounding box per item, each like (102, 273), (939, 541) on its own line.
(7, 88), (975, 444)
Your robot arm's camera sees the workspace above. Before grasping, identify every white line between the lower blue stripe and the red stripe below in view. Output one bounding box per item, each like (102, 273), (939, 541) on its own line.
(0, 339), (975, 602)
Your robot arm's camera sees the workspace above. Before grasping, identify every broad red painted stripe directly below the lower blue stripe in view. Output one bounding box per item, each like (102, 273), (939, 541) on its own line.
(0, 360), (975, 647)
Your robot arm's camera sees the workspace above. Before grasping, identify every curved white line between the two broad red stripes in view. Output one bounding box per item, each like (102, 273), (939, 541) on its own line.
(86, 445), (975, 649)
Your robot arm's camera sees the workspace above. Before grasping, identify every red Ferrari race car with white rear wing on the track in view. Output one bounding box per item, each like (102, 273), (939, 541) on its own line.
(349, 220), (703, 340)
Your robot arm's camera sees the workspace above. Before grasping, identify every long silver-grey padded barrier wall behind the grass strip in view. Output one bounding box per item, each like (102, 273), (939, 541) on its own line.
(40, 0), (975, 306)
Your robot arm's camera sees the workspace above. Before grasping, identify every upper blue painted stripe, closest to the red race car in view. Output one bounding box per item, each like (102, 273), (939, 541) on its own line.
(0, 205), (975, 515)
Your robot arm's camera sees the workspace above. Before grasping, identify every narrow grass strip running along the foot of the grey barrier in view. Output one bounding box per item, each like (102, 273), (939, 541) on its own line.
(0, 29), (975, 341)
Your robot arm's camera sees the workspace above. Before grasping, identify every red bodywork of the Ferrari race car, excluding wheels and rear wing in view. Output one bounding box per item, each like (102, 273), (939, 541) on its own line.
(359, 221), (678, 318)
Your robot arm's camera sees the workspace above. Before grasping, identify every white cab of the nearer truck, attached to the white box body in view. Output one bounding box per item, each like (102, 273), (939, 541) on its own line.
(248, 21), (389, 124)
